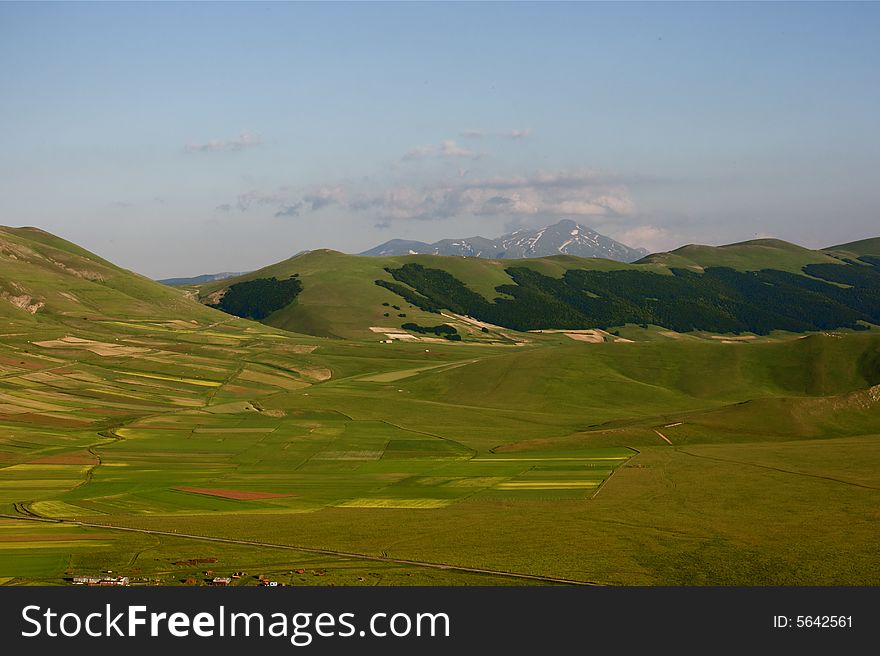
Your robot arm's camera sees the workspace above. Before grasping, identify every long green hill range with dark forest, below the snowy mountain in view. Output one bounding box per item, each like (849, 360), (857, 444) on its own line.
(200, 239), (880, 340)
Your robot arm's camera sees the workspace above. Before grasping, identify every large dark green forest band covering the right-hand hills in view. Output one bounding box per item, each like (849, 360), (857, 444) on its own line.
(376, 257), (880, 335)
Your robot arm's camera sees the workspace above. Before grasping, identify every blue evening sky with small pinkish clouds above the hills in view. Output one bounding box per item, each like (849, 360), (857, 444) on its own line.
(0, 2), (880, 278)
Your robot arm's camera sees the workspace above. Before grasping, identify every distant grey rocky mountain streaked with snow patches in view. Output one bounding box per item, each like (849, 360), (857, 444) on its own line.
(361, 219), (648, 262)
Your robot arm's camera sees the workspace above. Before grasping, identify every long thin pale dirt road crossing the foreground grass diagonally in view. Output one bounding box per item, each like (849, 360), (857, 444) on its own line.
(0, 513), (603, 587)
